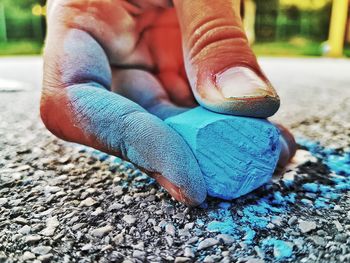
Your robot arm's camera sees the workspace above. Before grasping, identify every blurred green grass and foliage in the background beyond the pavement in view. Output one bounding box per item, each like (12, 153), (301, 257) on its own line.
(0, 0), (350, 56)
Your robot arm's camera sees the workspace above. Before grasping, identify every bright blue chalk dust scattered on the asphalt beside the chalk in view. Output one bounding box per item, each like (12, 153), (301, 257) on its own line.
(76, 137), (350, 260)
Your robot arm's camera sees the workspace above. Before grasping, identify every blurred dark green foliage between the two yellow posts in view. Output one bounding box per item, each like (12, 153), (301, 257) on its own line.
(255, 0), (331, 42)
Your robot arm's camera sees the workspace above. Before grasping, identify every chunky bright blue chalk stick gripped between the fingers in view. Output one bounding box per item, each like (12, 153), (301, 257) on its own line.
(165, 107), (281, 200)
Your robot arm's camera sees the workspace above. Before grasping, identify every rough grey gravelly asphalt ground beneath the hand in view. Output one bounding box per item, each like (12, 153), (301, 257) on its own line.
(0, 58), (350, 263)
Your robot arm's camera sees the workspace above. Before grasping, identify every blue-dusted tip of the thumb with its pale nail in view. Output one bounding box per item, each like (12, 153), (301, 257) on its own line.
(194, 67), (280, 118)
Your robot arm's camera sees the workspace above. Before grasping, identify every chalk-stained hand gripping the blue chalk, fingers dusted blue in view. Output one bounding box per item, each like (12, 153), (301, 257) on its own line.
(41, 0), (290, 205)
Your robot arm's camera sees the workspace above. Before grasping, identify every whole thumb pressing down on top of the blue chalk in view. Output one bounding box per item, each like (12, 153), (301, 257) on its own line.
(174, 0), (279, 118)
